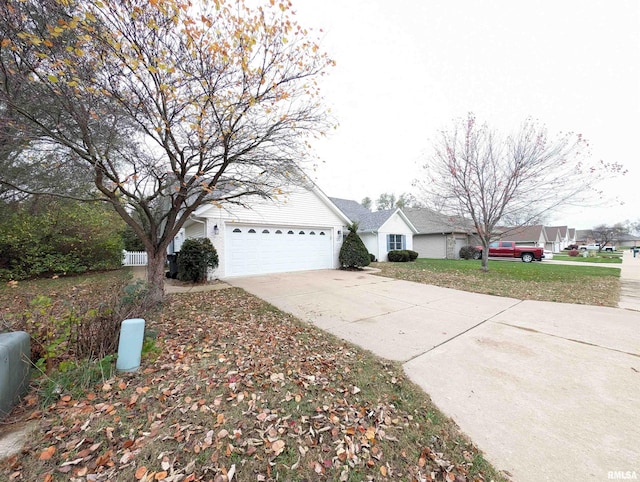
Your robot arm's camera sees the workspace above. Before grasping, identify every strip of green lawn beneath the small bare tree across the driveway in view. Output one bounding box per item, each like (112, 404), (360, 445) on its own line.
(371, 259), (620, 306)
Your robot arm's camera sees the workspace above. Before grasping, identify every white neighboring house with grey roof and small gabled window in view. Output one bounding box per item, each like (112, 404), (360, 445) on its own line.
(330, 198), (418, 261)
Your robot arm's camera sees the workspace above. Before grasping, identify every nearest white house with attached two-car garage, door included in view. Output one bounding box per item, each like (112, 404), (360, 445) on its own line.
(176, 183), (350, 278)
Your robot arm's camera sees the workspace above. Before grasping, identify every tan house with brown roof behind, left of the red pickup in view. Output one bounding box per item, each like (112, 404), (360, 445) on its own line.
(405, 208), (478, 259)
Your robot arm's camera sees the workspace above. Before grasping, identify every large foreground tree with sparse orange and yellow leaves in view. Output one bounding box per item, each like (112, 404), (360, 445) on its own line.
(0, 0), (333, 300)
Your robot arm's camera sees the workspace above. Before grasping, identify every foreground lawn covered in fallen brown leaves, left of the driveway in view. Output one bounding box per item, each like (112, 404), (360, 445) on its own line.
(0, 272), (504, 482)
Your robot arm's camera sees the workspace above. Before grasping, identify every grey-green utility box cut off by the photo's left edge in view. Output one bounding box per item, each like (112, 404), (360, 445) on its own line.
(0, 331), (31, 420)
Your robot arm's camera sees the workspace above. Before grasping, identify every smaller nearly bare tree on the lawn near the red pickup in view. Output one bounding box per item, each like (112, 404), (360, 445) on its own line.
(416, 114), (624, 270)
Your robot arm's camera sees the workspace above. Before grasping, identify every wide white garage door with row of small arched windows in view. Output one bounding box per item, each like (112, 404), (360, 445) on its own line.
(225, 226), (333, 276)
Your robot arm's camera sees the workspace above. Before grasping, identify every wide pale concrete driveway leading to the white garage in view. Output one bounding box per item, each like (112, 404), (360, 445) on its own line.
(231, 270), (640, 482)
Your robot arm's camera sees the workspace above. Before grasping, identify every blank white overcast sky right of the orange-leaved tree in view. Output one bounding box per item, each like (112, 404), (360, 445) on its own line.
(293, 0), (640, 229)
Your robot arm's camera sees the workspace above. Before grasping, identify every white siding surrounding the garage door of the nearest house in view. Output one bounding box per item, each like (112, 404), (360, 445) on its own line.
(192, 188), (346, 278)
